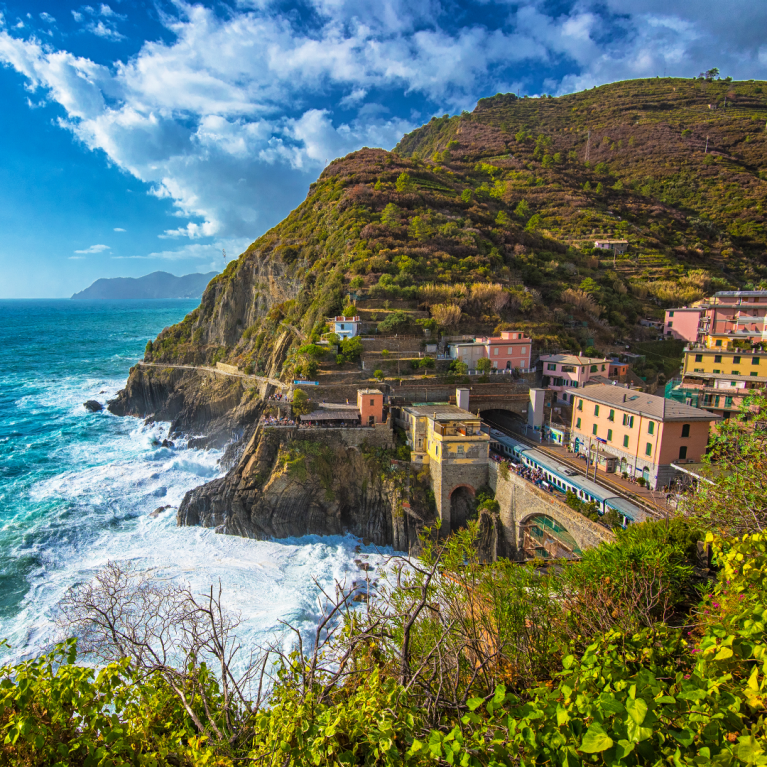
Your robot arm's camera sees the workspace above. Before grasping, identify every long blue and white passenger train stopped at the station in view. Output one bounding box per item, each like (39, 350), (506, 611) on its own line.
(483, 426), (647, 527)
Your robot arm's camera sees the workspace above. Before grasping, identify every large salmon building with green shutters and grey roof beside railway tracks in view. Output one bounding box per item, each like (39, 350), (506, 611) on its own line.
(570, 385), (720, 489)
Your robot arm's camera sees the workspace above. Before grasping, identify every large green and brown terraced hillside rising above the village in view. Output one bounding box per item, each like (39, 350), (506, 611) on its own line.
(141, 78), (767, 375)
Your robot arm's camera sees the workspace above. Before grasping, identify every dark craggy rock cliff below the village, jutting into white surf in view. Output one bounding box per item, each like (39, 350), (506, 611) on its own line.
(177, 429), (433, 553)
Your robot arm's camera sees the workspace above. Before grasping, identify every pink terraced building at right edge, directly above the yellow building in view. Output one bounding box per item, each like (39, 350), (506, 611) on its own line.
(663, 290), (767, 343)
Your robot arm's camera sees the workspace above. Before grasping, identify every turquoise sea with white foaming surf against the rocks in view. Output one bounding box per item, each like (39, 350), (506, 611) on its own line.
(0, 300), (389, 662)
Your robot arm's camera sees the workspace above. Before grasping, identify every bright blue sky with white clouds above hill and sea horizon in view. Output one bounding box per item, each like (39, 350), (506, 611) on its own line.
(0, 0), (767, 298)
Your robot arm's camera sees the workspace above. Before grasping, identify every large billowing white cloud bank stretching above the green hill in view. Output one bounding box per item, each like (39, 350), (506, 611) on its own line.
(0, 0), (767, 258)
